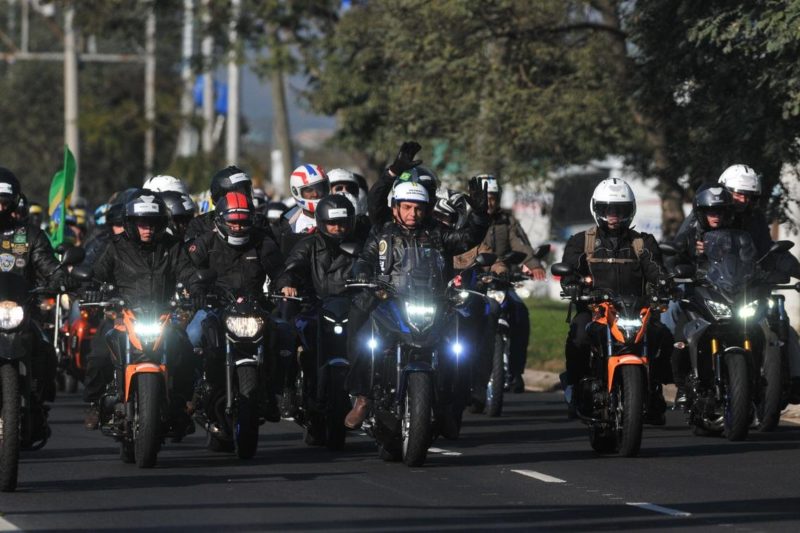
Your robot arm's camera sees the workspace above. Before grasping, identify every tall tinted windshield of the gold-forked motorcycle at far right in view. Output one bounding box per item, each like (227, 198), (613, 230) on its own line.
(703, 230), (756, 295)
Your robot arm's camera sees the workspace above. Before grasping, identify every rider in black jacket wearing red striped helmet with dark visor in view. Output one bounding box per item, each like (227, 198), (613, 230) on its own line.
(186, 191), (283, 422)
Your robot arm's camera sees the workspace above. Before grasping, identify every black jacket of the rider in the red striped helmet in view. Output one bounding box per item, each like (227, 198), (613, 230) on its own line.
(188, 228), (283, 295)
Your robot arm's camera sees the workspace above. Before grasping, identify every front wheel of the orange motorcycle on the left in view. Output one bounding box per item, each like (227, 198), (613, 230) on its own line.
(133, 373), (164, 468)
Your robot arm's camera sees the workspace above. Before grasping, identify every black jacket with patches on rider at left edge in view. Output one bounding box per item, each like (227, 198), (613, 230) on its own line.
(0, 223), (64, 287)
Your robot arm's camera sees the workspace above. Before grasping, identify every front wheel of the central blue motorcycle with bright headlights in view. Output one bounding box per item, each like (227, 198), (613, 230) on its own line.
(402, 372), (433, 466)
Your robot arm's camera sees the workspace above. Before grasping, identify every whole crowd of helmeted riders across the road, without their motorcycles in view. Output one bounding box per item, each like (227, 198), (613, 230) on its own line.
(0, 142), (800, 456)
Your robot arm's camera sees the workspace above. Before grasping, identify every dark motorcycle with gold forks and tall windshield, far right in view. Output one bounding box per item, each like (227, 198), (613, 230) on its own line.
(669, 229), (792, 441)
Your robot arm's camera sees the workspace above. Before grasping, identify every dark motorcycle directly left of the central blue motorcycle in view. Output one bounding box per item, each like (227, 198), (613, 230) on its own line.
(288, 296), (350, 450)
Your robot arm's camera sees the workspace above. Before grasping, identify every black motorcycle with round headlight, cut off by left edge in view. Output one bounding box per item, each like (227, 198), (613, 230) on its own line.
(0, 248), (83, 492)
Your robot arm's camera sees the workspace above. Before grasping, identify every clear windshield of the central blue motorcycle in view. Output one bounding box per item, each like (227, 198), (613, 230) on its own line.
(392, 242), (445, 298)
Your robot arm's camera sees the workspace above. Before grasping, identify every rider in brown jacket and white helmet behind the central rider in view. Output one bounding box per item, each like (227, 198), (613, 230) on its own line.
(469, 174), (547, 393)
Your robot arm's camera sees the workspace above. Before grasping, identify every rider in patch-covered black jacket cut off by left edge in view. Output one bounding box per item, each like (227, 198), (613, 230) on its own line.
(0, 167), (64, 446)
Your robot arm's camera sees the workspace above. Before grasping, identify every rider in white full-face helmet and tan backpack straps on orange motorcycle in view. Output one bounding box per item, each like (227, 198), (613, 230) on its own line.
(561, 178), (671, 425)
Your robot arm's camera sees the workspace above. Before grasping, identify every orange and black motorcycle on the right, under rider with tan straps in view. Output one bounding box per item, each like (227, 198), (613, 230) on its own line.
(551, 263), (667, 457)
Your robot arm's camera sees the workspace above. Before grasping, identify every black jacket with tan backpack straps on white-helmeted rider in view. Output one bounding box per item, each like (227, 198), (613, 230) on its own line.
(561, 228), (664, 296)
